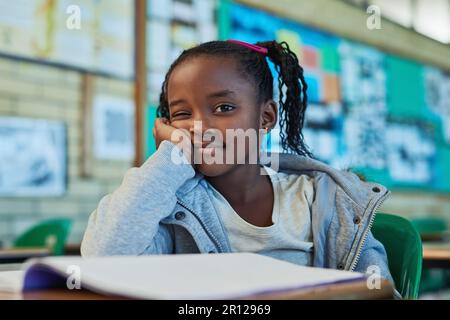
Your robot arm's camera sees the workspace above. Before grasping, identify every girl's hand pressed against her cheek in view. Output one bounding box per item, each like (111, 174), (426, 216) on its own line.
(153, 118), (192, 163)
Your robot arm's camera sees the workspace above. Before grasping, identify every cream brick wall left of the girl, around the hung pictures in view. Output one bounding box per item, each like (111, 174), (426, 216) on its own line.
(0, 58), (134, 245)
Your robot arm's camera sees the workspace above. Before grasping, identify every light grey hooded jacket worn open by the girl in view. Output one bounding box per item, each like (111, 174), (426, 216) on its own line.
(81, 141), (392, 281)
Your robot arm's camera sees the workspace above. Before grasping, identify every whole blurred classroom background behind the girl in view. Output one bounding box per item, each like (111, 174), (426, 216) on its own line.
(0, 0), (450, 298)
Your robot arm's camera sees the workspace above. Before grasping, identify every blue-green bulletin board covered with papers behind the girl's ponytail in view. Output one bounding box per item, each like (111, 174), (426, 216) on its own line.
(223, 3), (450, 192)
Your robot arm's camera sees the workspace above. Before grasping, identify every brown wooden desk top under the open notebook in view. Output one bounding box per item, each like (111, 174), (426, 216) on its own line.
(0, 279), (393, 300)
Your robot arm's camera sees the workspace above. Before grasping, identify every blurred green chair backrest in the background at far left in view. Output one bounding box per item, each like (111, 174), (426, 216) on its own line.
(13, 218), (72, 255)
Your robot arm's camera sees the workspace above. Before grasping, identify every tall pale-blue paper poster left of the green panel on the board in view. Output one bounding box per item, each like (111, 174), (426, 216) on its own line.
(339, 40), (387, 170)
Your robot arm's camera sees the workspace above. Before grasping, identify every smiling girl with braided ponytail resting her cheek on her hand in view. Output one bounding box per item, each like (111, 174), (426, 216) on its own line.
(81, 40), (392, 281)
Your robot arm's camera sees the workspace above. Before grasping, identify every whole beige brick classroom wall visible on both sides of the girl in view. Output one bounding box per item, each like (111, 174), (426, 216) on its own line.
(0, 0), (450, 245)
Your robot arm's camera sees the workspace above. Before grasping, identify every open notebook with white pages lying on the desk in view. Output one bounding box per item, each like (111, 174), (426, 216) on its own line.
(0, 253), (364, 300)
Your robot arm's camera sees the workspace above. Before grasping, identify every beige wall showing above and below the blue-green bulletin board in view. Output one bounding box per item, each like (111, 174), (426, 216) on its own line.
(237, 0), (450, 225)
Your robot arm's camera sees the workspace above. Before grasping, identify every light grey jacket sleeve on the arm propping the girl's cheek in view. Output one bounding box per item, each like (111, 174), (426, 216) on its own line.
(81, 141), (195, 257)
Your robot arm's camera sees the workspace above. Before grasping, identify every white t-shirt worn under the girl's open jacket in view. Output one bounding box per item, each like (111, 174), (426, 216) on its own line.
(205, 167), (314, 265)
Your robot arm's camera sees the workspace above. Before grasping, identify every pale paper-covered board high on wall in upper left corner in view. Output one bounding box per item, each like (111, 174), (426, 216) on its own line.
(0, 0), (134, 79)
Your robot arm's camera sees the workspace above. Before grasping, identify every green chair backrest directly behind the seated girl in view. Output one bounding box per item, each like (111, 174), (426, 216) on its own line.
(372, 213), (422, 299)
